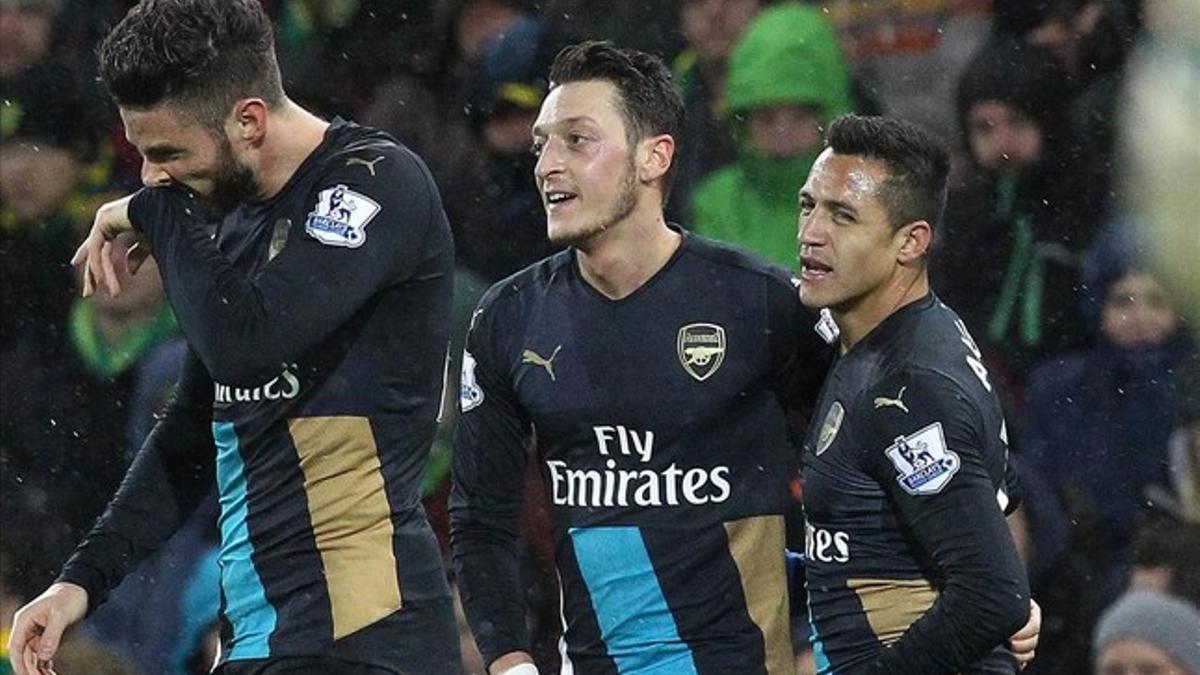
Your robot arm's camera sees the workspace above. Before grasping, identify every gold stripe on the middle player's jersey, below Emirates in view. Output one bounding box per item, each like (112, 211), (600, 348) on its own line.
(725, 515), (796, 675)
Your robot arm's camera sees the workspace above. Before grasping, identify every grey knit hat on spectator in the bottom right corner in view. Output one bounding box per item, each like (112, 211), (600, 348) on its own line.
(1092, 591), (1200, 675)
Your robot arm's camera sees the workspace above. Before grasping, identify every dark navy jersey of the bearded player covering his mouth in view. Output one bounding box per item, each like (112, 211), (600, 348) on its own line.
(65, 120), (463, 671)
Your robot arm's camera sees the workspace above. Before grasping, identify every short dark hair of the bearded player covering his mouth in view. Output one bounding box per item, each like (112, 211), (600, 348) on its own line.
(100, 0), (284, 129)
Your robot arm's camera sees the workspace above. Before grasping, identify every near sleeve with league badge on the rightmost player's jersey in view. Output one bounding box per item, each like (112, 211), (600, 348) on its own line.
(857, 371), (1030, 675)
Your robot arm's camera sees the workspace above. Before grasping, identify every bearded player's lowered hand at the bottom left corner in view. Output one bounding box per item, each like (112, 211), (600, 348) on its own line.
(8, 581), (88, 675)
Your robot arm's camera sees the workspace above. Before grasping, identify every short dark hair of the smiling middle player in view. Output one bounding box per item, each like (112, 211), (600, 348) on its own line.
(550, 40), (684, 192)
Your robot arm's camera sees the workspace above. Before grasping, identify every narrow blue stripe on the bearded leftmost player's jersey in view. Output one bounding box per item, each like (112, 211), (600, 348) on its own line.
(212, 422), (276, 661)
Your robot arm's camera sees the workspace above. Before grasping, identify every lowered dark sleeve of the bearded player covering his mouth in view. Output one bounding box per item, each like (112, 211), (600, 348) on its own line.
(58, 345), (216, 613)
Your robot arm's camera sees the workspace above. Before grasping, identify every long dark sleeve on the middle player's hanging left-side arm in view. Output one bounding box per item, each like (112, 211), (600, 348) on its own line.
(450, 291), (532, 663)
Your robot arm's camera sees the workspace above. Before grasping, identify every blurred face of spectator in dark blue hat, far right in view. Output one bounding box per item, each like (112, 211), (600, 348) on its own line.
(1100, 271), (1178, 348)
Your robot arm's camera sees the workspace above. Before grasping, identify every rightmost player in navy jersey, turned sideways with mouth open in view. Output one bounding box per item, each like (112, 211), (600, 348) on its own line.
(799, 117), (1030, 675)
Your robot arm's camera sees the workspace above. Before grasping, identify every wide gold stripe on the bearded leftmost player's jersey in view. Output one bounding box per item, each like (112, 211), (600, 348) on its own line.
(288, 417), (403, 639)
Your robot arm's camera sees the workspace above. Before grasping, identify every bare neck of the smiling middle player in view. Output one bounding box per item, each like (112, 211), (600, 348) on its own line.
(576, 207), (683, 300)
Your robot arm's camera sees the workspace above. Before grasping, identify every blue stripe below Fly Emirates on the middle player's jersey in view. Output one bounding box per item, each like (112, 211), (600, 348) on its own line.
(569, 527), (696, 675)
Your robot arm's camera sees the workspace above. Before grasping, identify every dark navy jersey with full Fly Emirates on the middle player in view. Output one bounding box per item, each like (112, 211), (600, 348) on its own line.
(450, 228), (827, 675)
